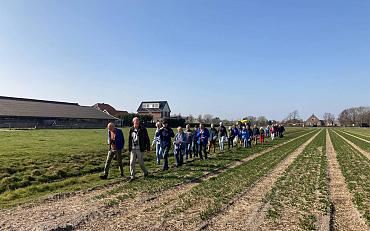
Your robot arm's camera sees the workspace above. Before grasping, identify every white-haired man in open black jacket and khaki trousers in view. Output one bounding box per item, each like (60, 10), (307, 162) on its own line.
(128, 117), (150, 181)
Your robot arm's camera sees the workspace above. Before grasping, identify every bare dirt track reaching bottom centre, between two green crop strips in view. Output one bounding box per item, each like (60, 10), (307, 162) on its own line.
(202, 131), (322, 231)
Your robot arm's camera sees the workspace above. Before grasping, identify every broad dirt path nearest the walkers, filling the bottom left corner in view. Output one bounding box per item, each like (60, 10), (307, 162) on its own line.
(0, 133), (308, 230)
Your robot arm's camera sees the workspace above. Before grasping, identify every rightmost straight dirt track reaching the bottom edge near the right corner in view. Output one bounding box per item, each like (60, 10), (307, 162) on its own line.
(326, 131), (369, 231)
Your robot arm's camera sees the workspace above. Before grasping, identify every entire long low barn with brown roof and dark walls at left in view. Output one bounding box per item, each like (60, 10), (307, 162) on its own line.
(0, 96), (117, 128)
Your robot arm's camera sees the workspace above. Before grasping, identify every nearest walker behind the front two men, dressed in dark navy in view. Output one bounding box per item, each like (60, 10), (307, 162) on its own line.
(156, 119), (175, 171)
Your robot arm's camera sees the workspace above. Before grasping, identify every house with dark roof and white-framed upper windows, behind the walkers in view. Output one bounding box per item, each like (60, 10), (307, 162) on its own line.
(137, 101), (171, 121)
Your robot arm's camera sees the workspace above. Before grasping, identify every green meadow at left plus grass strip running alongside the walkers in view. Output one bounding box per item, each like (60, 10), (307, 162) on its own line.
(0, 129), (308, 207)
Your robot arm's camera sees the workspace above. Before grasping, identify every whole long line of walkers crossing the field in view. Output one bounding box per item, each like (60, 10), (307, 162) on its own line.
(100, 117), (285, 181)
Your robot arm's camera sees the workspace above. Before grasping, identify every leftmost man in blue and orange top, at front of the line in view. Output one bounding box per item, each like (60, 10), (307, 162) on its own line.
(100, 123), (125, 180)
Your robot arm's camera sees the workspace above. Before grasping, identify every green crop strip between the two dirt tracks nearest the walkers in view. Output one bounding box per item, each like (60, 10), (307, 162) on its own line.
(159, 130), (313, 227)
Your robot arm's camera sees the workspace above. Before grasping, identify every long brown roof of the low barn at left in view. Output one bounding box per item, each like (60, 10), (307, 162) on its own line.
(0, 96), (117, 120)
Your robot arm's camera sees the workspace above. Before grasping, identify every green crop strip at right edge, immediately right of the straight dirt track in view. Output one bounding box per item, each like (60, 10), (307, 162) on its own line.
(330, 131), (370, 225)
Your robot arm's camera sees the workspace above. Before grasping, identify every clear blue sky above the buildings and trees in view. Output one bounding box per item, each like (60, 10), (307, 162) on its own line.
(0, 0), (370, 119)
